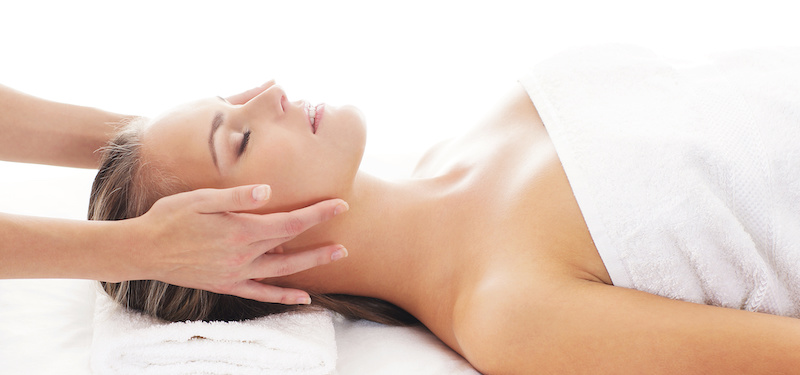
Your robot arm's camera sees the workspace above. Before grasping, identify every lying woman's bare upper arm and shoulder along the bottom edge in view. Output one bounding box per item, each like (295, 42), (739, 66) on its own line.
(460, 281), (800, 374)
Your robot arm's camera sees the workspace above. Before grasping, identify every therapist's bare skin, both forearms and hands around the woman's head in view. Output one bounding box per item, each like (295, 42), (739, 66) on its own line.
(0, 82), (347, 304)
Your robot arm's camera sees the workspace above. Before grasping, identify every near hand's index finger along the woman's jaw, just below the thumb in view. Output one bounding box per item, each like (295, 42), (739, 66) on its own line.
(249, 199), (350, 239)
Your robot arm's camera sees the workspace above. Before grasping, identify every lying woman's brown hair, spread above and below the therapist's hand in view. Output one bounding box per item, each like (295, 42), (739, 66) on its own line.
(88, 118), (419, 325)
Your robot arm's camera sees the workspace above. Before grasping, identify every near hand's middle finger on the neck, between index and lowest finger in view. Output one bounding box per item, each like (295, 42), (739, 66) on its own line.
(246, 244), (347, 279)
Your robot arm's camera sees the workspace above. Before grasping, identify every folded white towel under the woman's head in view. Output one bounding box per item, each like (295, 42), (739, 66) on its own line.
(91, 292), (337, 375)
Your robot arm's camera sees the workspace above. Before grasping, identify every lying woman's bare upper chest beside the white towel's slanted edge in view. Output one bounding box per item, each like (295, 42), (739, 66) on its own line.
(416, 88), (608, 280)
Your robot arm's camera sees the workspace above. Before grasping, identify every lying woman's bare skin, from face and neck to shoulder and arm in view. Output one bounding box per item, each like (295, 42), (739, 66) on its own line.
(144, 81), (800, 374)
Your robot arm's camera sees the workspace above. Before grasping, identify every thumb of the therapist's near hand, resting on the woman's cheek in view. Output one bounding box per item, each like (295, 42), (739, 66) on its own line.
(194, 185), (272, 214)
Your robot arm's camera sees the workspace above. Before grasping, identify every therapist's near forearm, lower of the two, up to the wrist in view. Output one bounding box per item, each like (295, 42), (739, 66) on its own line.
(0, 213), (139, 281)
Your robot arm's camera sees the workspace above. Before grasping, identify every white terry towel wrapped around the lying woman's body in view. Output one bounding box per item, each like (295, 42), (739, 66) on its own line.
(521, 45), (800, 317)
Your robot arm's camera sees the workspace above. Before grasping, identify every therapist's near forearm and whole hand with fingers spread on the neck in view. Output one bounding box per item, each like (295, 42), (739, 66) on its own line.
(0, 186), (347, 304)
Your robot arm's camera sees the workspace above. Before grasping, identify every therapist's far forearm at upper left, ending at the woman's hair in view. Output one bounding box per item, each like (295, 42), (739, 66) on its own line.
(0, 85), (130, 168)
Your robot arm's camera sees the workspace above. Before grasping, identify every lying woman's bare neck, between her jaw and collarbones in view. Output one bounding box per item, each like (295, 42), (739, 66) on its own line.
(270, 172), (460, 322)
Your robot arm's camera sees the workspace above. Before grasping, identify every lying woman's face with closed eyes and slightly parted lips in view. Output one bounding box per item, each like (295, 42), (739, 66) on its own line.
(142, 86), (366, 211)
